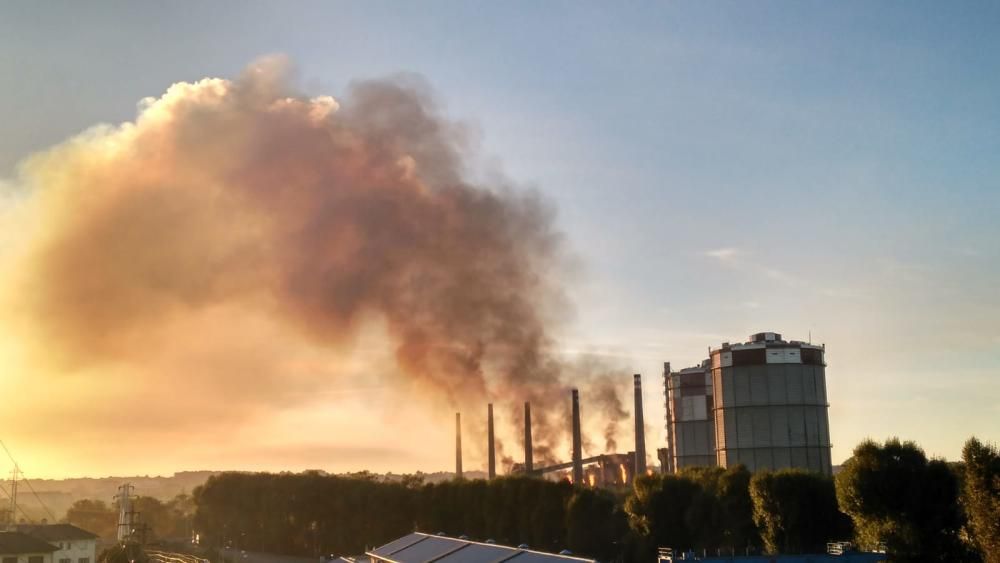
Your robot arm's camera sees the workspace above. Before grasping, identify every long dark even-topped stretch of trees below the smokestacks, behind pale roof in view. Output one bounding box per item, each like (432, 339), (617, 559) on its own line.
(195, 472), (625, 556)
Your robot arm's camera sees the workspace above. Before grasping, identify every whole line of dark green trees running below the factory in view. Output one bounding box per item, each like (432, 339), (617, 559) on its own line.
(68, 439), (1000, 563)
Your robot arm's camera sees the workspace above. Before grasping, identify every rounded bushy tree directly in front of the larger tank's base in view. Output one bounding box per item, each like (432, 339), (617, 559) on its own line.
(750, 469), (850, 554)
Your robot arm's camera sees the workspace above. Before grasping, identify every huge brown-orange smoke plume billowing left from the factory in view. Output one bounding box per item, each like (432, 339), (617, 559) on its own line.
(4, 58), (624, 472)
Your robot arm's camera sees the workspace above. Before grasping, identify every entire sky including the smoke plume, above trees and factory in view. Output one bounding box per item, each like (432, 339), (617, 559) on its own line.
(0, 2), (1000, 477)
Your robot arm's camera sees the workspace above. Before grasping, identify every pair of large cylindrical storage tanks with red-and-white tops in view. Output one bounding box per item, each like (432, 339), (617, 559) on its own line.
(661, 332), (832, 475)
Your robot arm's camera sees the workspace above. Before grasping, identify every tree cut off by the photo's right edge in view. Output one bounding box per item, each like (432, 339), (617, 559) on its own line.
(962, 438), (1000, 563)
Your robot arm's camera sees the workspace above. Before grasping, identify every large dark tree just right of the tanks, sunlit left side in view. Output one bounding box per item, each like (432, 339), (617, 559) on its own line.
(836, 438), (970, 561)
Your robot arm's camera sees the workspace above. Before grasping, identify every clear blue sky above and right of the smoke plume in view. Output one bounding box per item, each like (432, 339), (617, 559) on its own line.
(0, 1), (1000, 476)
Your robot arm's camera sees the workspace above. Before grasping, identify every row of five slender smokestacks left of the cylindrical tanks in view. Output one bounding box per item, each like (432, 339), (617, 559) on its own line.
(455, 373), (646, 483)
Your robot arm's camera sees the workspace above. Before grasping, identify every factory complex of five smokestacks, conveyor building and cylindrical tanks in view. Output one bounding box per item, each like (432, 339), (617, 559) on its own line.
(455, 332), (832, 487)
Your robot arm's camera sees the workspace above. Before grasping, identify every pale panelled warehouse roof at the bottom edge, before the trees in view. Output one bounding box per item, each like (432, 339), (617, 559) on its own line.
(367, 532), (594, 563)
